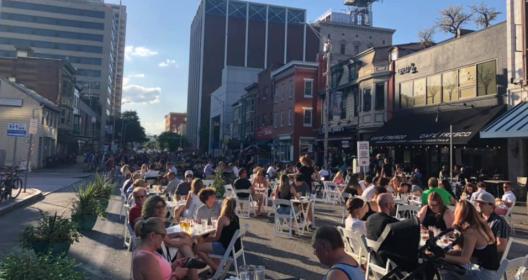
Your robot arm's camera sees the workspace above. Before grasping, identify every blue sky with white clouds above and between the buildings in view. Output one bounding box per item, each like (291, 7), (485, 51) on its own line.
(106, 0), (506, 134)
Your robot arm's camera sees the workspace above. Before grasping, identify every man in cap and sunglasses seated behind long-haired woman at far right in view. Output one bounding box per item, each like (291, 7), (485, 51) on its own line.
(475, 192), (511, 254)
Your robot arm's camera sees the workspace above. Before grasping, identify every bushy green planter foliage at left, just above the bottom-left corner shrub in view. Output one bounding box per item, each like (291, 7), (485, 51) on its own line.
(21, 212), (79, 248)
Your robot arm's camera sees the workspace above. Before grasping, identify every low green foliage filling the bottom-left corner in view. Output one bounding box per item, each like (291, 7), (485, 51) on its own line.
(0, 250), (84, 280)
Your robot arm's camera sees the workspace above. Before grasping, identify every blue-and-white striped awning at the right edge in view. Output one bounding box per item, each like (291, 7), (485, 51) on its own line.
(480, 102), (528, 138)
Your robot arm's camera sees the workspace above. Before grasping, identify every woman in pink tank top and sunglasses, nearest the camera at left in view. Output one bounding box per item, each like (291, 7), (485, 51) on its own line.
(132, 218), (188, 280)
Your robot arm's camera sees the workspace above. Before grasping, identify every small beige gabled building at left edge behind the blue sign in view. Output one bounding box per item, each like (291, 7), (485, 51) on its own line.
(0, 79), (60, 169)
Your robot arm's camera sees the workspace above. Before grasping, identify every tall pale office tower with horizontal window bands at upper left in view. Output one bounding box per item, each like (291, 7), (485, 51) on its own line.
(0, 0), (126, 143)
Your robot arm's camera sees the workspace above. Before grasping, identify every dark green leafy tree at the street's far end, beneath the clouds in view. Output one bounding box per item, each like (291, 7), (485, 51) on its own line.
(116, 111), (147, 144)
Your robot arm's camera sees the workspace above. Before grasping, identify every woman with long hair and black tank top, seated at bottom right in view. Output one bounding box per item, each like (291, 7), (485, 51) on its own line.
(444, 200), (500, 280)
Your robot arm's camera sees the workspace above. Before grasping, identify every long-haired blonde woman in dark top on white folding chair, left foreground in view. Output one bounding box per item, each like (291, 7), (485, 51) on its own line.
(197, 198), (240, 270)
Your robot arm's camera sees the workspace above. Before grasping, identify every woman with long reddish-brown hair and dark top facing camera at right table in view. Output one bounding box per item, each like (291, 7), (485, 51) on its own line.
(417, 192), (455, 230)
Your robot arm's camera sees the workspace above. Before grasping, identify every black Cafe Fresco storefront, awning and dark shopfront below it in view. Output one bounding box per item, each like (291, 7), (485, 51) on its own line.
(370, 105), (508, 177)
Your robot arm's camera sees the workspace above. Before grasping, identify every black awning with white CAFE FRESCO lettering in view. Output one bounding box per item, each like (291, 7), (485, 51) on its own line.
(370, 106), (504, 145)
